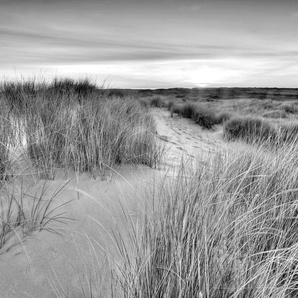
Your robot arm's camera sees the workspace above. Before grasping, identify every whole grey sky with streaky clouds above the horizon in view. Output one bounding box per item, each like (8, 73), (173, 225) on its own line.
(0, 0), (298, 88)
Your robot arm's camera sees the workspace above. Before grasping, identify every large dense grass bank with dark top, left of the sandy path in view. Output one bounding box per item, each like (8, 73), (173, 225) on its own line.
(1, 78), (162, 179)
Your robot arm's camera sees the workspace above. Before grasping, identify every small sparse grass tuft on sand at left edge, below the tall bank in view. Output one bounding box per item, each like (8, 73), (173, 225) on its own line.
(0, 181), (71, 249)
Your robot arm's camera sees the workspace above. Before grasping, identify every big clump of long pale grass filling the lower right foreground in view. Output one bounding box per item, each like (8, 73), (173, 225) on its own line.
(114, 146), (298, 297)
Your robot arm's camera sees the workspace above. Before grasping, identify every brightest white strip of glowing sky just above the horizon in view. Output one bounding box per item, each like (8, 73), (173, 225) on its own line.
(39, 60), (249, 88)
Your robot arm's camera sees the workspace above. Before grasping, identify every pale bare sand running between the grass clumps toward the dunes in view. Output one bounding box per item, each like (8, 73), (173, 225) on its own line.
(0, 109), (224, 297)
